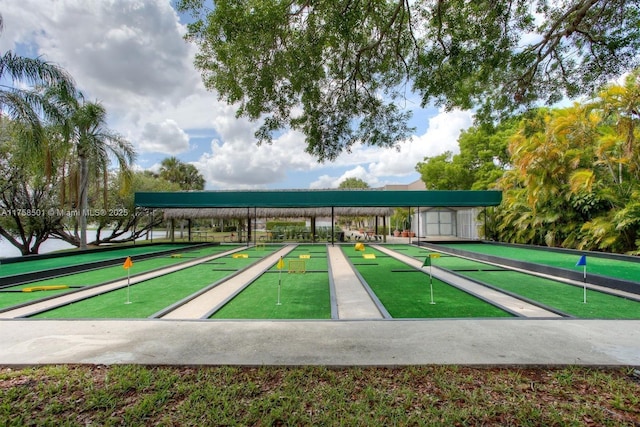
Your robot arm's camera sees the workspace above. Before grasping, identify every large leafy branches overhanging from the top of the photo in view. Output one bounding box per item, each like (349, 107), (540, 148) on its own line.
(178, 0), (640, 161)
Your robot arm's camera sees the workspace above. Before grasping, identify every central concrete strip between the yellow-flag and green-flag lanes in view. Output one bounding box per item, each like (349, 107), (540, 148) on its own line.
(327, 246), (383, 319)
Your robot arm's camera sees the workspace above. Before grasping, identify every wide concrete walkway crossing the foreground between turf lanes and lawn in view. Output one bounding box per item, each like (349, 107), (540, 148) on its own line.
(0, 319), (640, 367)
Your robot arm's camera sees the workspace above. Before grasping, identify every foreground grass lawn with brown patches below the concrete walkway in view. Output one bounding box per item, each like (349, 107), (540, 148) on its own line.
(0, 365), (640, 426)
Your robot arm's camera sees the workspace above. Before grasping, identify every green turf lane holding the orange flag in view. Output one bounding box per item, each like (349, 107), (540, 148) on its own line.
(32, 248), (276, 319)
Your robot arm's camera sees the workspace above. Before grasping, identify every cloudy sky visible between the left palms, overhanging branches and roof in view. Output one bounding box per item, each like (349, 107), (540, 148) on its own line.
(0, 0), (472, 190)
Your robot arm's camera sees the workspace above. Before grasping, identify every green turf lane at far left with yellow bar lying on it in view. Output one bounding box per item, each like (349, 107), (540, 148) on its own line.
(0, 246), (228, 309)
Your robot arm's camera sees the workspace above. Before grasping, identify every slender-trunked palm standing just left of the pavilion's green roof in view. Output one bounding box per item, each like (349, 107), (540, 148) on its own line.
(61, 97), (136, 249)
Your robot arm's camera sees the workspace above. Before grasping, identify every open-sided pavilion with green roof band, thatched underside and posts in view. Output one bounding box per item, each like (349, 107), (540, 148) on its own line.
(135, 189), (502, 244)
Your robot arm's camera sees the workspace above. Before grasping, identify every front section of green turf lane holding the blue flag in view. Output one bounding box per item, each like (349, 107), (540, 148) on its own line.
(458, 271), (640, 319)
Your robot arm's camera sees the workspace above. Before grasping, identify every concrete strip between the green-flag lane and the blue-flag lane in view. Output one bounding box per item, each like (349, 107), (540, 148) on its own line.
(371, 245), (562, 318)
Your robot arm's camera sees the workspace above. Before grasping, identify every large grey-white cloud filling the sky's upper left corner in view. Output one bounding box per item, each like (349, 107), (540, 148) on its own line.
(0, 0), (202, 127)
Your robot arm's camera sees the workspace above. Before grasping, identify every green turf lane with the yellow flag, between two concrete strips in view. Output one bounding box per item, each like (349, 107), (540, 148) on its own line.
(211, 245), (331, 319)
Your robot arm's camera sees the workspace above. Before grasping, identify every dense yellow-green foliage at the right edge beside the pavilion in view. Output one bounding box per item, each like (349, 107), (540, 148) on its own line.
(493, 72), (640, 254)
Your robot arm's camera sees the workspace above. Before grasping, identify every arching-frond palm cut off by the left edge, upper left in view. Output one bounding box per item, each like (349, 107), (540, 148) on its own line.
(0, 15), (75, 155)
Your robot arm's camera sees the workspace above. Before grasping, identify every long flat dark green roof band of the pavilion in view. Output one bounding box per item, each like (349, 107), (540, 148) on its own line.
(135, 190), (502, 208)
